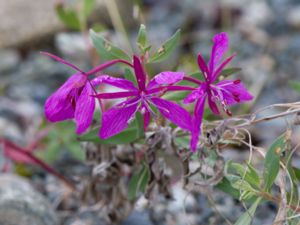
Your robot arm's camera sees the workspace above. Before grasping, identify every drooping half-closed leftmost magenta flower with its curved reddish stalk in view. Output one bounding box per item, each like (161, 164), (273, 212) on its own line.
(42, 52), (132, 134)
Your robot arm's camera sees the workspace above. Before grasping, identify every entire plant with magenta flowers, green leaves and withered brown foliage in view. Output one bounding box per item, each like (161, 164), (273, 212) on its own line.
(36, 25), (300, 225)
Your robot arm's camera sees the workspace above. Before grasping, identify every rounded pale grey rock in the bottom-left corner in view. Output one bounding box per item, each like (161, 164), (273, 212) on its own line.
(0, 174), (59, 225)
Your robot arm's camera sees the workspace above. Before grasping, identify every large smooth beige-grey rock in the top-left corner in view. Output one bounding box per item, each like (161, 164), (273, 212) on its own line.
(0, 0), (63, 48)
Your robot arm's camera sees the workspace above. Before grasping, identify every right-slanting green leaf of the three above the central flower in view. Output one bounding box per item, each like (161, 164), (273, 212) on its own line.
(149, 30), (180, 63)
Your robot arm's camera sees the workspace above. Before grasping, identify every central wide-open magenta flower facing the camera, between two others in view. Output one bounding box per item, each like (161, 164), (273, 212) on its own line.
(96, 56), (194, 139)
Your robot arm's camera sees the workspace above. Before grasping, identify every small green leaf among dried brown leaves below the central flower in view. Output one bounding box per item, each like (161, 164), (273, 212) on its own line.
(128, 162), (150, 200)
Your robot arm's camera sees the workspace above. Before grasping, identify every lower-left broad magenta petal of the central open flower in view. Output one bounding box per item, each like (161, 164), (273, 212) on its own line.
(99, 98), (139, 139)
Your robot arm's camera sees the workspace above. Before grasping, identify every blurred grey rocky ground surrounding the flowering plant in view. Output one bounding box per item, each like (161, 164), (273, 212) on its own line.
(0, 0), (300, 225)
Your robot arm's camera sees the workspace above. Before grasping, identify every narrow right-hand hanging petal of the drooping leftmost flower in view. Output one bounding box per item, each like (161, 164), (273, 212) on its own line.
(74, 83), (95, 134)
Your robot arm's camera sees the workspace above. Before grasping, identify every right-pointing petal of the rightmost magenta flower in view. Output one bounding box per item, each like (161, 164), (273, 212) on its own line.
(216, 80), (253, 105)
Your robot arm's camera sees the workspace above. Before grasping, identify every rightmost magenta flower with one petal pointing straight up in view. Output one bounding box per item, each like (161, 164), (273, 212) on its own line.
(184, 32), (253, 151)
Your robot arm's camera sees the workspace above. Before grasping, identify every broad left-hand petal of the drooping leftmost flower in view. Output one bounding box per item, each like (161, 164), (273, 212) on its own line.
(45, 74), (87, 122)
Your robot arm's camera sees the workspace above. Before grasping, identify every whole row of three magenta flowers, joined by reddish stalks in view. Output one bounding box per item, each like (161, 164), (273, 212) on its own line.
(44, 32), (253, 151)
